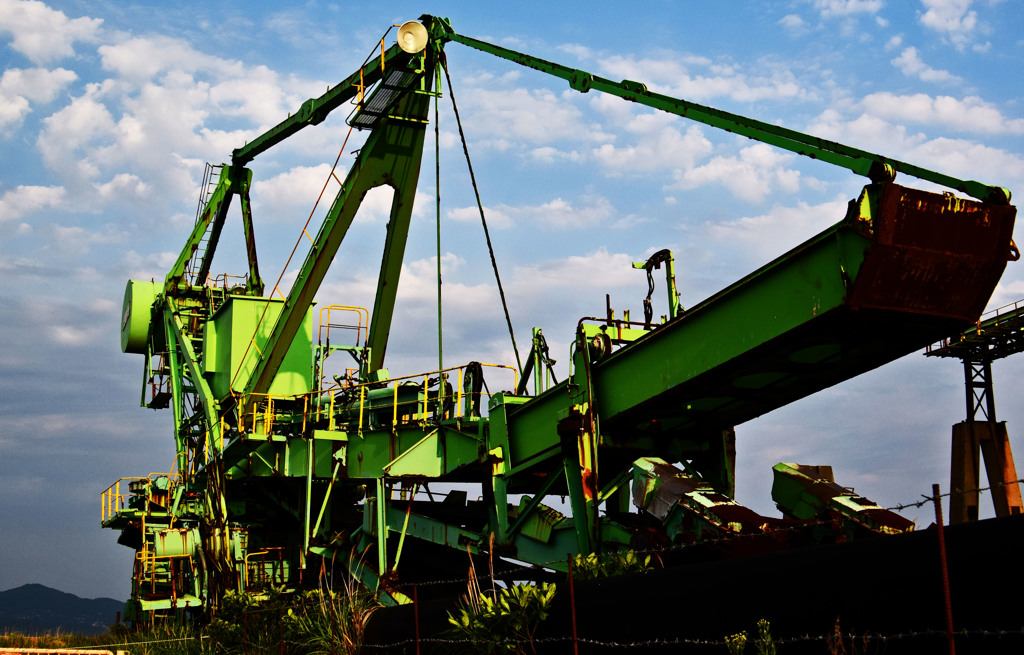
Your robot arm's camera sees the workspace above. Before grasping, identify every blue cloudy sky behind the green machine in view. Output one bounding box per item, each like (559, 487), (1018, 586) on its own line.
(0, 0), (1024, 598)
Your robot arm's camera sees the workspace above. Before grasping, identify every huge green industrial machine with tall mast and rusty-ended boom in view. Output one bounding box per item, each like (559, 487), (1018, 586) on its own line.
(102, 16), (1018, 621)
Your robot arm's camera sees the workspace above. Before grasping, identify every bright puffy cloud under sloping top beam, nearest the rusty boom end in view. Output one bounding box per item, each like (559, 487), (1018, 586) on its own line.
(673, 143), (801, 203)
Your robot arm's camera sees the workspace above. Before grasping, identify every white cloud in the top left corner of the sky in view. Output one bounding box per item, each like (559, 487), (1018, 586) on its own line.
(0, 0), (102, 63)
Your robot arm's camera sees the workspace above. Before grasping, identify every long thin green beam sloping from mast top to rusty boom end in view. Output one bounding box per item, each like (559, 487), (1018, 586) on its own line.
(430, 18), (1010, 205)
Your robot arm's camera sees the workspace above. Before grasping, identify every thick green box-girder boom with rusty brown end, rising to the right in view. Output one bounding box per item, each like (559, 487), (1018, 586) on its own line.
(493, 184), (1015, 482)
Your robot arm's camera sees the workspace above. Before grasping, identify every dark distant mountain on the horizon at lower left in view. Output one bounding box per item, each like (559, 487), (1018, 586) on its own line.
(0, 584), (125, 635)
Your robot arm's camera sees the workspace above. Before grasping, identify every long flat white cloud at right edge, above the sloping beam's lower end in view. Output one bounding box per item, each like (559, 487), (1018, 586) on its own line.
(861, 92), (1024, 134)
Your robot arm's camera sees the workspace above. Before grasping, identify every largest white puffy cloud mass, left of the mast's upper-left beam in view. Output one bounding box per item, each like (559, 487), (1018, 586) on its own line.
(37, 36), (324, 214)
